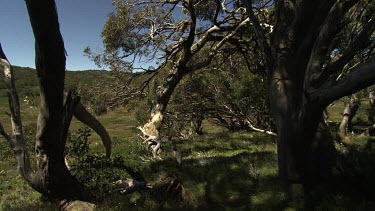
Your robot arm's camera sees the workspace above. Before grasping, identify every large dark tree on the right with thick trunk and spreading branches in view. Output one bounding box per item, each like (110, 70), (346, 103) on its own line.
(242, 0), (375, 186)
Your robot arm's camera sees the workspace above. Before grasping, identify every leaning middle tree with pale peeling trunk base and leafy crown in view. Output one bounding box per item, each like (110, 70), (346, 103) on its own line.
(86, 0), (258, 156)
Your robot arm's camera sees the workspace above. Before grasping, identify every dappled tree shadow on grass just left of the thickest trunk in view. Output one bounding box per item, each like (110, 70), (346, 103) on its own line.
(141, 152), (287, 210)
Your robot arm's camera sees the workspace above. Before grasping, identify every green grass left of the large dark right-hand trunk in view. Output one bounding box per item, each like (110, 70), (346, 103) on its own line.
(0, 98), (285, 210)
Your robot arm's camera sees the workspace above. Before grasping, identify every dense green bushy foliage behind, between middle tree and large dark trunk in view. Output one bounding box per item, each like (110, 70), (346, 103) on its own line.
(168, 54), (273, 134)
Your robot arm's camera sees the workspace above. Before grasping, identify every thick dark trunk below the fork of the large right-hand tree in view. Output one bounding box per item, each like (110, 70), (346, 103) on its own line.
(269, 69), (334, 189)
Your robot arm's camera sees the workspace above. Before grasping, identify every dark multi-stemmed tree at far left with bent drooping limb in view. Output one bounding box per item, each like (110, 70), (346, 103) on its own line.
(0, 0), (111, 200)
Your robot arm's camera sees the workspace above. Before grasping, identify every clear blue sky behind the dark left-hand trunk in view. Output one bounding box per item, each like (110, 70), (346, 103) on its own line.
(0, 0), (114, 70)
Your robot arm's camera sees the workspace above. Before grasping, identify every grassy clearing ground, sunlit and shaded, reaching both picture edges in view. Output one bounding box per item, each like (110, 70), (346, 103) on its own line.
(0, 97), (375, 210)
